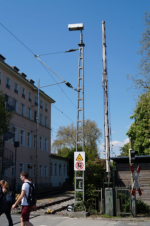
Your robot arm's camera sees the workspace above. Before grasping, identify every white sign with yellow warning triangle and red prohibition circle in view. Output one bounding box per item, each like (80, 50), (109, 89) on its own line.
(74, 151), (85, 171)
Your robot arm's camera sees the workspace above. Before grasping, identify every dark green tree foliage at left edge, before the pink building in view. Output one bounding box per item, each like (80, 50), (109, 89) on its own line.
(0, 91), (13, 145)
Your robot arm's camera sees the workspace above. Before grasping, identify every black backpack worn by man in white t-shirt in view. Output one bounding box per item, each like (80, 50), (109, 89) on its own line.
(25, 182), (36, 206)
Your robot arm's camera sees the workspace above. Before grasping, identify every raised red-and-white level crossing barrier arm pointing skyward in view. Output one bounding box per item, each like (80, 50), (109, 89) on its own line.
(102, 21), (110, 186)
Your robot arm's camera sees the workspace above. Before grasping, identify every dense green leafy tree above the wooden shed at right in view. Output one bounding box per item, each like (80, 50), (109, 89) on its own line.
(127, 91), (150, 155)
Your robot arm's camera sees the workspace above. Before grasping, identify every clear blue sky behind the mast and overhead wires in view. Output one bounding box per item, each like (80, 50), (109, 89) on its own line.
(0, 0), (150, 157)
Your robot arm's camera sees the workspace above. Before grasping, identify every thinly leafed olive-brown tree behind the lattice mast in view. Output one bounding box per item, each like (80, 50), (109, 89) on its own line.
(52, 119), (102, 159)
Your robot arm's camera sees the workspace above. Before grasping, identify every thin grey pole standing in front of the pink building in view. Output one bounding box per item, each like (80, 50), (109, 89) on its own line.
(35, 79), (40, 187)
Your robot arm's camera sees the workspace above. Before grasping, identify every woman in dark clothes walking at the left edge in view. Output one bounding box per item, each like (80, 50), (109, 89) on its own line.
(0, 180), (13, 226)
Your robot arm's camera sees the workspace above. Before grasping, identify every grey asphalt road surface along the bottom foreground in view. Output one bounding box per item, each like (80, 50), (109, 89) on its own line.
(0, 215), (150, 226)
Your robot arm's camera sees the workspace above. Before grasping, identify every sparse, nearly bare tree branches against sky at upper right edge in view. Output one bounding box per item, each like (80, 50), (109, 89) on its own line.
(127, 11), (150, 92)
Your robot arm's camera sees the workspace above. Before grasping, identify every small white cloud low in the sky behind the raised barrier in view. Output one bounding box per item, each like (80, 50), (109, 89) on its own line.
(100, 138), (129, 158)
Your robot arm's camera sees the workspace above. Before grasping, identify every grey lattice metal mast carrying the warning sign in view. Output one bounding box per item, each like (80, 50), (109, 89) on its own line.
(75, 30), (85, 203)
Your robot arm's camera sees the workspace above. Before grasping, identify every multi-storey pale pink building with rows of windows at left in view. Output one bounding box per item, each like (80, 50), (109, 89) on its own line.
(0, 55), (55, 185)
